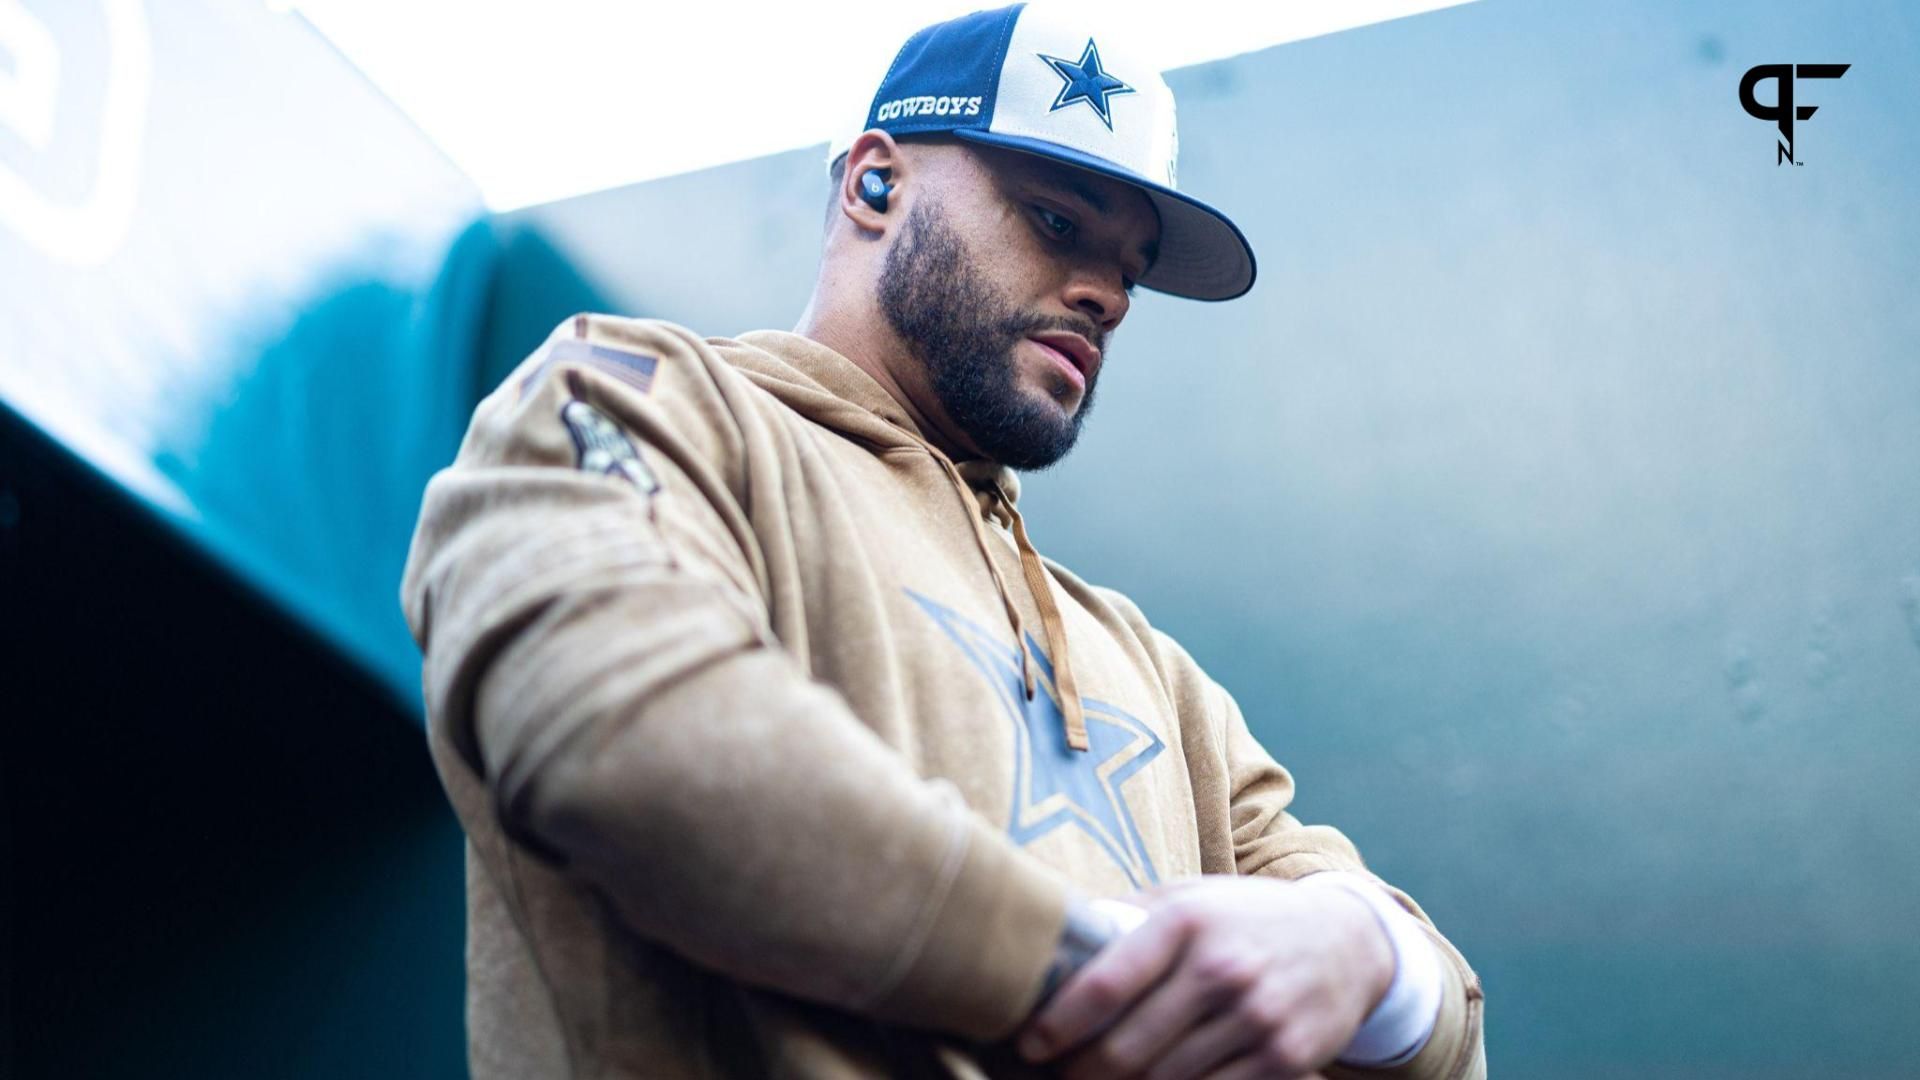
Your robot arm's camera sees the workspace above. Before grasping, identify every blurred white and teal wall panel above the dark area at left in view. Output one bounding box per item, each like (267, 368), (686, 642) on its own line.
(0, 2), (597, 709)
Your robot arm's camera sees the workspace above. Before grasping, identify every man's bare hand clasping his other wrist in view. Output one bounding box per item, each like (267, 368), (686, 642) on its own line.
(1018, 876), (1394, 1080)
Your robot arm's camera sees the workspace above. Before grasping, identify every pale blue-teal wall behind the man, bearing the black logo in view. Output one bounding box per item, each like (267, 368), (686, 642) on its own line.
(516, 0), (1920, 1080)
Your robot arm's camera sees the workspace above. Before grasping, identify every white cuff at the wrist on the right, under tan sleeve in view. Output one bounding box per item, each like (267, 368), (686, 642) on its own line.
(1300, 871), (1444, 1068)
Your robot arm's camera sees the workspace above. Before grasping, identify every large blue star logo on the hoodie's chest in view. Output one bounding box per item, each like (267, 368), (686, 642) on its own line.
(906, 588), (1165, 888)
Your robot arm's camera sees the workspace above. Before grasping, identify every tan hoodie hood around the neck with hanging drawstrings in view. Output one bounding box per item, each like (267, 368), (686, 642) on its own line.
(708, 331), (1089, 749)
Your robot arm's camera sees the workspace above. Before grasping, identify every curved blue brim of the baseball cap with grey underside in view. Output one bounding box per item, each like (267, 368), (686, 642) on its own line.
(941, 129), (1256, 300)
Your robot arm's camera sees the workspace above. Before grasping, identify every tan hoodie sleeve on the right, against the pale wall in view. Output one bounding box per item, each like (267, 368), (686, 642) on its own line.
(1096, 588), (1486, 1080)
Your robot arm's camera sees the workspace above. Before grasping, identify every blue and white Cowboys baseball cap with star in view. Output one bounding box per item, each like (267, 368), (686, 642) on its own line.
(828, 4), (1254, 300)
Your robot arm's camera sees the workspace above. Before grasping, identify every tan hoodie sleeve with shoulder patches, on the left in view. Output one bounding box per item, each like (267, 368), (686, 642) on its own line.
(401, 317), (1066, 1040)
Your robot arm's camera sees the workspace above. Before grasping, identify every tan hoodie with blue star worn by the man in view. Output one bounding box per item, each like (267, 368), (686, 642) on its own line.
(401, 315), (1484, 1080)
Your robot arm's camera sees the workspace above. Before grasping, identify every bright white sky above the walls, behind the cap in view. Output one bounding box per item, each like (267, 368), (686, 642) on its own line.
(294, 0), (1467, 209)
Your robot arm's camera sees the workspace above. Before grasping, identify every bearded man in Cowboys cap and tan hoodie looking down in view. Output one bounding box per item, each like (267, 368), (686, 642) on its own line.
(403, 6), (1484, 1078)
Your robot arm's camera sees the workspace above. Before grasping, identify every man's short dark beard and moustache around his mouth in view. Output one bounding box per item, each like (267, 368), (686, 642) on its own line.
(879, 200), (1104, 471)
